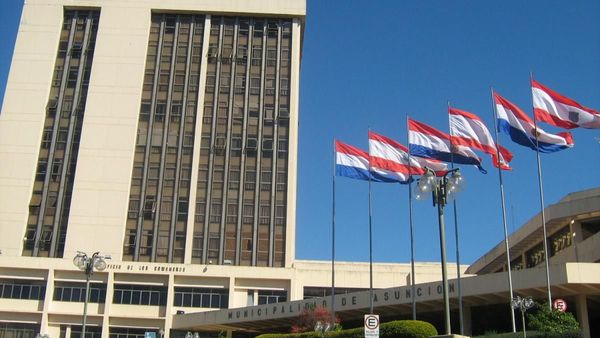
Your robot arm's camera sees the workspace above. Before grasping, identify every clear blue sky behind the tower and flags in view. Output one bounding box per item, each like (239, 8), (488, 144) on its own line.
(0, 0), (600, 263)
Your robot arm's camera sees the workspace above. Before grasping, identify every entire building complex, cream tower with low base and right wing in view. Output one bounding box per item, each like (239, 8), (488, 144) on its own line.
(0, 0), (600, 338)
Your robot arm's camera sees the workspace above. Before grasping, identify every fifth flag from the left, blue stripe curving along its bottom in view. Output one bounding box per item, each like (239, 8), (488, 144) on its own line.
(494, 93), (573, 153)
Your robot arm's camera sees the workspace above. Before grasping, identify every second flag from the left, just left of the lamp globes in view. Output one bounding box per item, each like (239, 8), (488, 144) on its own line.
(369, 131), (448, 183)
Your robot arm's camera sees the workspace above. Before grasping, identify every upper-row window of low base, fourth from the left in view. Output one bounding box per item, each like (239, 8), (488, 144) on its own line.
(173, 287), (229, 309)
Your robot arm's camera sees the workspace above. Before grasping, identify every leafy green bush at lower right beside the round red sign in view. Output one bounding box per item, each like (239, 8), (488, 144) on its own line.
(527, 303), (579, 335)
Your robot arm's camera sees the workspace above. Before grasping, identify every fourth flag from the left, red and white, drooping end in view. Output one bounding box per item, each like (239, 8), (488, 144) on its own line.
(448, 107), (513, 170)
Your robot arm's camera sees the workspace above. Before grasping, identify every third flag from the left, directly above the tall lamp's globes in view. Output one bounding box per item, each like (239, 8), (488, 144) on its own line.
(408, 119), (486, 173)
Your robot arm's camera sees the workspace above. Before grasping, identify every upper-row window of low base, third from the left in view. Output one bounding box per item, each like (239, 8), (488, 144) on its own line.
(113, 284), (167, 306)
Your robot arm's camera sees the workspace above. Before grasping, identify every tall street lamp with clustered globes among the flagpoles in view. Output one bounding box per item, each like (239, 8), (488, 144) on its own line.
(416, 167), (464, 335)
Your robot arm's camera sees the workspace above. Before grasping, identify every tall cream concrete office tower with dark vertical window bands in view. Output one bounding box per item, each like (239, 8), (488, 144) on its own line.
(0, 0), (305, 267)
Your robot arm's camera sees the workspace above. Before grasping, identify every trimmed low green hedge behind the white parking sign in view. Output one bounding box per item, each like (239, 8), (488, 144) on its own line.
(257, 320), (438, 338)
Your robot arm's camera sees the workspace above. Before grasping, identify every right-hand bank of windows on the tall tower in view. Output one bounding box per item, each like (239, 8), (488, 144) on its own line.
(190, 13), (292, 266)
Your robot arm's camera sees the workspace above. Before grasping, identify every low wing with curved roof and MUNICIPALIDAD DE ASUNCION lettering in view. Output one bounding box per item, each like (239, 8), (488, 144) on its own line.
(173, 188), (600, 337)
